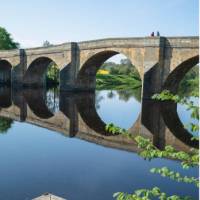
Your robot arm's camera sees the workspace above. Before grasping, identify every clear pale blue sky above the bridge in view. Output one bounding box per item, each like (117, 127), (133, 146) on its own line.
(0, 0), (199, 47)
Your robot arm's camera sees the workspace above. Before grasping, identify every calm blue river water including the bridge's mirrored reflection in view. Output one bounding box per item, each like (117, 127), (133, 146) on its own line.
(0, 88), (198, 200)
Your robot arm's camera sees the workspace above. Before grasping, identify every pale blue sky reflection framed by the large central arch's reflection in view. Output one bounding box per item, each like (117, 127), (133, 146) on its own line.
(95, 90), (141, 129)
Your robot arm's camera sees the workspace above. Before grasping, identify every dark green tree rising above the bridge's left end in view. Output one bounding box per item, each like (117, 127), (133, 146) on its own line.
(0, 27), (19, 50)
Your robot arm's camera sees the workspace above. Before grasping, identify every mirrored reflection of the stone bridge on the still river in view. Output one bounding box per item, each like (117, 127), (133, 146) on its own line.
(0, 89), (198, 151)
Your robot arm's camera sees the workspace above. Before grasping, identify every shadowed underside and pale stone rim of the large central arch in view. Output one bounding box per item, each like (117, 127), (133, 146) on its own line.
(76, 49), (141, 90)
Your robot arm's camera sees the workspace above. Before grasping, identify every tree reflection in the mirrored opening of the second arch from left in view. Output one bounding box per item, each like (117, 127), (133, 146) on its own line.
(45, 88), (59, 113)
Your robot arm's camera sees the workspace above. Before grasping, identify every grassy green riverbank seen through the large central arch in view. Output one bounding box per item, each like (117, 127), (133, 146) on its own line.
(96, 74), (142, 89)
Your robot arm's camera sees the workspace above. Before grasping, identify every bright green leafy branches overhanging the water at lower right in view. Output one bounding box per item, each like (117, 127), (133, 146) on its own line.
(106, 90), (199, 200)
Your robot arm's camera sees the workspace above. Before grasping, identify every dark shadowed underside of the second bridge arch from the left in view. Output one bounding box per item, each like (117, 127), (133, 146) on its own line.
(24, 57), (59, 86)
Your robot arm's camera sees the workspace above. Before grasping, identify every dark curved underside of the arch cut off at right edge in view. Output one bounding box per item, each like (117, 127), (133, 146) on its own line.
(163, 55), (199, 93)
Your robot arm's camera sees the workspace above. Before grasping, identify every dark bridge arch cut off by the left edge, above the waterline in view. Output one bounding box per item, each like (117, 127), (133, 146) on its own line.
(0, 60), (12, 85)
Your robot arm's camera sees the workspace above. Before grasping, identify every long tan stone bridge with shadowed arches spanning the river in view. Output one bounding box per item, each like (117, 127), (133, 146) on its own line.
(0, 37), (199, 98)
